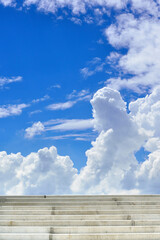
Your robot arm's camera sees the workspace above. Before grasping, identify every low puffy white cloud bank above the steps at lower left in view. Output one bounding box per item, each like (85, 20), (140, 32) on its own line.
(0, 147), (77, 195)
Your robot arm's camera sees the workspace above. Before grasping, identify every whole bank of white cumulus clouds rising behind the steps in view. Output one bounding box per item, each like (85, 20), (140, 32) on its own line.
(0, 87), (160, 194)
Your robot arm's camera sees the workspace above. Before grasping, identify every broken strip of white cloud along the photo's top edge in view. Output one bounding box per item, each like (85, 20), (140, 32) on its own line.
(21, 0), (159, 16)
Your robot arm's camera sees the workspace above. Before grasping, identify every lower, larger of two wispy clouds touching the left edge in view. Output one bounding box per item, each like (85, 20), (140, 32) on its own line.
(0, 103), (30, 118)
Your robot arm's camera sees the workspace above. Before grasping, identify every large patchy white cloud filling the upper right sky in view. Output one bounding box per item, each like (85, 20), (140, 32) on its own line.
(106, 13), (160, 92)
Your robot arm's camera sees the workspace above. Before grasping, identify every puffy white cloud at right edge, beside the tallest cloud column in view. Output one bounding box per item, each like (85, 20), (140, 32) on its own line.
(130, 87), (160, 193)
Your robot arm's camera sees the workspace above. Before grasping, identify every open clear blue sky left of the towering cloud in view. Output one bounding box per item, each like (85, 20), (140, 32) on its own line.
(0, 6), (110, 167)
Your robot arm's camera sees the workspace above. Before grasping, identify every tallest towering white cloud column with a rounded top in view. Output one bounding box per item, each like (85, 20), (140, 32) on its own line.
(72, 87), (144, 193)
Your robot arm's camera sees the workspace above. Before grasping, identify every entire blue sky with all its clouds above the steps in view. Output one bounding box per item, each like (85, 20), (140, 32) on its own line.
(0, 0), (160, 194)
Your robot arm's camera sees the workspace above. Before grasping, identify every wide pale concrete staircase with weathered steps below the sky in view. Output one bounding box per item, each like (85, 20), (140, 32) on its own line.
(0, 195), (160, 240)
